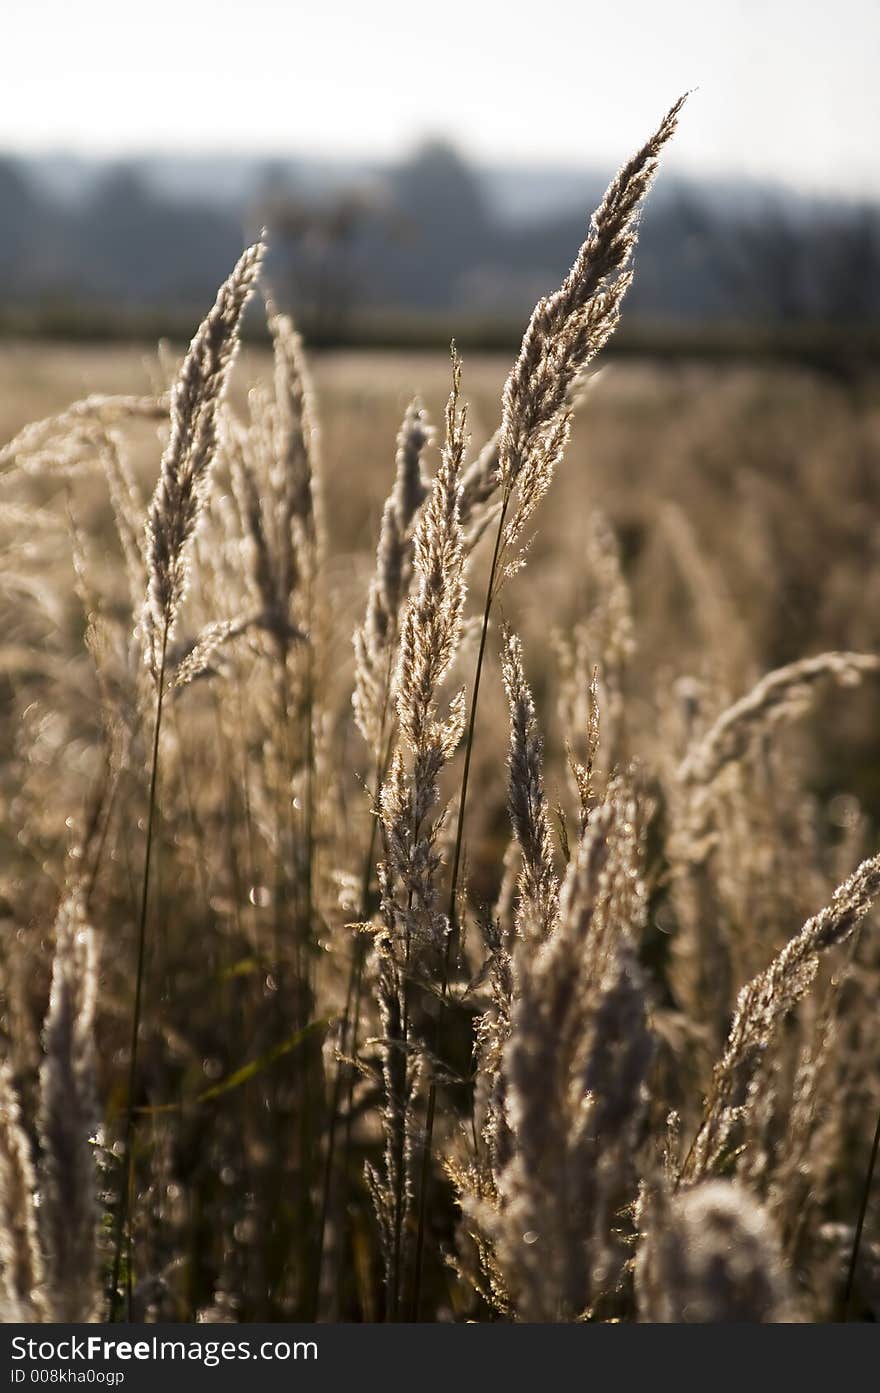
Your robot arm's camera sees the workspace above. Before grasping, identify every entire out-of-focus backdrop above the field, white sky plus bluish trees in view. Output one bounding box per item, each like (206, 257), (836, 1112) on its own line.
(0, 0), (880, 357)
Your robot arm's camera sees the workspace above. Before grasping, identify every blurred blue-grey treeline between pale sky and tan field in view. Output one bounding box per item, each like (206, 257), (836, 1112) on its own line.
(0, 141), (880, 345)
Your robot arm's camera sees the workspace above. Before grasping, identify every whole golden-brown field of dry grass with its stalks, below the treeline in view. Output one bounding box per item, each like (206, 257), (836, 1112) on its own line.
(0, 100), (880, 1322)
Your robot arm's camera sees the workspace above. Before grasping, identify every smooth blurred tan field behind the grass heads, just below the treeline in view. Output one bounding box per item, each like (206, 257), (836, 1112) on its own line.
(6, 341), (880, 664)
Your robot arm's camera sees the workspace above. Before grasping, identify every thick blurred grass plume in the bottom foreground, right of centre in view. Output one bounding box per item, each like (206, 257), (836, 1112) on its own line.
(462, 795), (653, 1321)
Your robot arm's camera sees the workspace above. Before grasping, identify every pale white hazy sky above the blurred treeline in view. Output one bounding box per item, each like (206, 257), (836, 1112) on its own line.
(6, 0), (880, 195)
